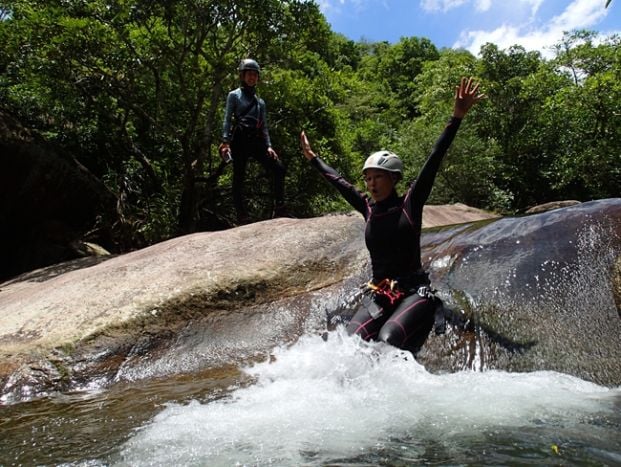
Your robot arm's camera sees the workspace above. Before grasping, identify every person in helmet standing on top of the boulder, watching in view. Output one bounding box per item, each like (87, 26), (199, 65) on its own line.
(219, 58), (288, 224)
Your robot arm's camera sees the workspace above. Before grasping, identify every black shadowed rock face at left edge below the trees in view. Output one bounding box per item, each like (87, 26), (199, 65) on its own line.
(0, 140), (115, 280)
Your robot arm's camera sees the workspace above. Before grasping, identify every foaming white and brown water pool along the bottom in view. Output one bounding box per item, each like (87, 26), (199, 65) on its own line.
(0, 329), (621, 466)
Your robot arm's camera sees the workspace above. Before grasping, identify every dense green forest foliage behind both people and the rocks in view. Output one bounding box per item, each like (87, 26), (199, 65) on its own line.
(0, 0), (621, 252)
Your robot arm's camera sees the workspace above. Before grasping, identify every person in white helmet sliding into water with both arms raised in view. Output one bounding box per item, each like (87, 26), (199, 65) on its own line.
(300, 78), (485, 355)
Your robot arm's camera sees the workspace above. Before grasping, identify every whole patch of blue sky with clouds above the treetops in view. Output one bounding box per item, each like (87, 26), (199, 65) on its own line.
(317, 0), (621, 56)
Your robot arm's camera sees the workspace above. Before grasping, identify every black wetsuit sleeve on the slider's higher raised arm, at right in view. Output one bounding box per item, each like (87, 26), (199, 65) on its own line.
(404, 117), (461, 219)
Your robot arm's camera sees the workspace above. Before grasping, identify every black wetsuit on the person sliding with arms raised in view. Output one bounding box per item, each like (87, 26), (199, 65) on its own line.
(311, 117), (461, 353)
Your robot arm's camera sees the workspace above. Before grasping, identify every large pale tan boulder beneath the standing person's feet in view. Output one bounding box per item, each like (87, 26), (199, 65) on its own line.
(0, 205), (494, 399)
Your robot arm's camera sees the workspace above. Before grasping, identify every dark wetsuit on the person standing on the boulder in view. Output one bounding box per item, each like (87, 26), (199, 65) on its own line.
(222, 85), (285, 216)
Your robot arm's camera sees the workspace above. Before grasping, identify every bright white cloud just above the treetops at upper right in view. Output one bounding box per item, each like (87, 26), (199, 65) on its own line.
(454, 0), (607, 57)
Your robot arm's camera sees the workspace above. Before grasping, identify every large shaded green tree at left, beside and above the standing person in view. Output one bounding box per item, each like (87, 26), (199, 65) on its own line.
(3, 0), (331, 241)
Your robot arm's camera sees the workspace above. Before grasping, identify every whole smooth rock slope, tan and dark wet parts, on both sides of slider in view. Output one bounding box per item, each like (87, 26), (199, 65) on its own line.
(0, 199), (621, 402)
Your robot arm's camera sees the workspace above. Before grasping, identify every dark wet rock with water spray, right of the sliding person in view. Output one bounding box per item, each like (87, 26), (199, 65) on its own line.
(420, 198), (621, 386)
